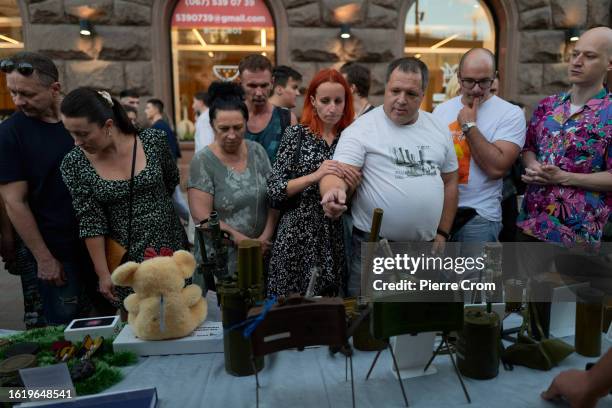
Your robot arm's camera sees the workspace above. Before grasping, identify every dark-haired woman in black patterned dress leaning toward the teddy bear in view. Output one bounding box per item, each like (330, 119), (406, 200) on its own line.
(61, 88), (187, 307)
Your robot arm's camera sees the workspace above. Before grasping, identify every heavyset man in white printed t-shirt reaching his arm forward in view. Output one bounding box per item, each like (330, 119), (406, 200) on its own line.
(319, 58), (457, 295)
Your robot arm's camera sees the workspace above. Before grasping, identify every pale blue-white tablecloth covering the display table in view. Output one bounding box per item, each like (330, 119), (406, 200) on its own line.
(103, 298), (612, 408)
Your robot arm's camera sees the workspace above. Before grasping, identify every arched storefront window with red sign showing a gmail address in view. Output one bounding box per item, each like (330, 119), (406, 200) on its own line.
(171, 0), (275, 139)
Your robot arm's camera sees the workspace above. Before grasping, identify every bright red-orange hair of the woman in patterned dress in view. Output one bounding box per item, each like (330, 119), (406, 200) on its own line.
(302, 68), (355, 137)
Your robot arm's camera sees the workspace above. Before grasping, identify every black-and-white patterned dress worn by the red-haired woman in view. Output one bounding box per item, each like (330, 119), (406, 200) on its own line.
(267, 125), (345, 296)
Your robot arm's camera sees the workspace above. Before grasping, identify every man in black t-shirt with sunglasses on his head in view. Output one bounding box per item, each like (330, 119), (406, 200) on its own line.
(0, 52), (93, 324)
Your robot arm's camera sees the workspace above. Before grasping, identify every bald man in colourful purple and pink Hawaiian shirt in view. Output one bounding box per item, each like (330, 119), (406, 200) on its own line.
(517, 27), (612, 247)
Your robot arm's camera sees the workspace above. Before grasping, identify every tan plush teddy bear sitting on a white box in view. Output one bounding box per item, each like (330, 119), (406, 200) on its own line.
(111, 251), (208, 340)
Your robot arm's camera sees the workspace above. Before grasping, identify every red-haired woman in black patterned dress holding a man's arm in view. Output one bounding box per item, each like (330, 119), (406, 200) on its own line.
(267, 69), (360, 296)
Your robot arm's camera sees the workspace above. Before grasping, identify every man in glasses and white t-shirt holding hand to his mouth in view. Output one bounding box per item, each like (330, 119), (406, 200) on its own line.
(433, 48), (525, 244)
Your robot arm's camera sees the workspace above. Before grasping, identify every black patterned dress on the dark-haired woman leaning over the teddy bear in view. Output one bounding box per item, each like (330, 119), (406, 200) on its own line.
(61, 129), (187, 306)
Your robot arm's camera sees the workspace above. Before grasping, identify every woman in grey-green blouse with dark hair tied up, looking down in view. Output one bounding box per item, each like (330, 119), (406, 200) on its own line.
(188, 82), (277, 280)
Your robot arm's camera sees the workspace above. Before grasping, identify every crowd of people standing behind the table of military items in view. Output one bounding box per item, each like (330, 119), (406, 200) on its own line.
(0, 27), (612, 406)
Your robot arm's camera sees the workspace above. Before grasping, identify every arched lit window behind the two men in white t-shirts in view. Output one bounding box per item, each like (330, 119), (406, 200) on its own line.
(404, 0), (495, 111)
